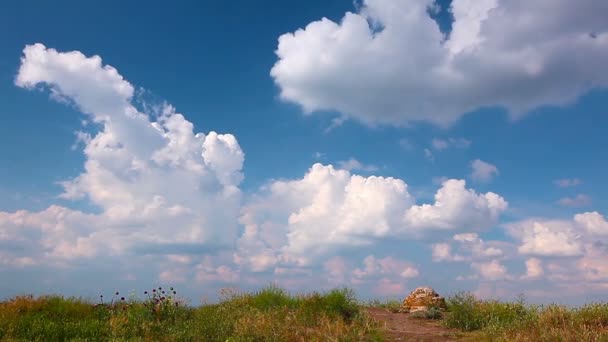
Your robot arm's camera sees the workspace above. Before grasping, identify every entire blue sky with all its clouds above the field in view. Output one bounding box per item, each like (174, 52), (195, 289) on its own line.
(0, 0), (608, 304)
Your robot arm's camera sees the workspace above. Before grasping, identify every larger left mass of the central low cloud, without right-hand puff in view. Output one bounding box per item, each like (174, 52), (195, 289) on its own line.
(239, 164), (413, 263)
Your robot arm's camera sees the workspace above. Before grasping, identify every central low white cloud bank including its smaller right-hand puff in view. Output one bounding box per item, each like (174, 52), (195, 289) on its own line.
(235, 164), (507, 271)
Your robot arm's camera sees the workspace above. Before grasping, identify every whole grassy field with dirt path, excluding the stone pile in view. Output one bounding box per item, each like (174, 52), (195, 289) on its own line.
(0, 286), (608, 342)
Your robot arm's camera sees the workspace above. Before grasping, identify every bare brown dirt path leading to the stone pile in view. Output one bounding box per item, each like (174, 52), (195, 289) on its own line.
(367, 308), (458, 342)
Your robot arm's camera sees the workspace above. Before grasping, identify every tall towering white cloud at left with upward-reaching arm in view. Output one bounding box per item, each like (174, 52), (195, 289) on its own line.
(0, 44), (244, 268)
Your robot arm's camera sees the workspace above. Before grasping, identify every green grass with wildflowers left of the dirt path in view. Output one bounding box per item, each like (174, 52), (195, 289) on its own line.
(0, 286), (382, 342)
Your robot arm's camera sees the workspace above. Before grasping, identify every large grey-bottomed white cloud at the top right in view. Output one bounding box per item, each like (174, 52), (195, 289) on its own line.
(271, 0), (608, 125)
